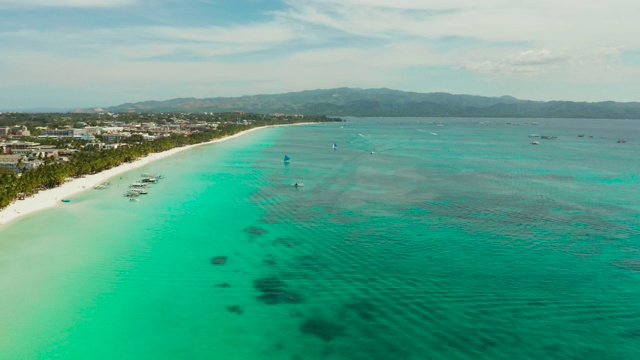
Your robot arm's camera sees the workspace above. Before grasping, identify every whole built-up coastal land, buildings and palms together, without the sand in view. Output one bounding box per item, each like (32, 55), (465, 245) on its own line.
(0, 111), (337, 209)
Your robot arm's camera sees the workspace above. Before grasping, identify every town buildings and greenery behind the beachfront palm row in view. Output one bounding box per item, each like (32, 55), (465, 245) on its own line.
(0, 111), (304, 174)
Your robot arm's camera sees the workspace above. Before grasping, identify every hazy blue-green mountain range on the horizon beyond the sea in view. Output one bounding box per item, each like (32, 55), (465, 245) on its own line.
(99, 88), (640, 119)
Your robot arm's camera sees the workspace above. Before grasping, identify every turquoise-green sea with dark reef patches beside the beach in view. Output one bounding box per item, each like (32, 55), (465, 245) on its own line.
(0, 118), (640, 360)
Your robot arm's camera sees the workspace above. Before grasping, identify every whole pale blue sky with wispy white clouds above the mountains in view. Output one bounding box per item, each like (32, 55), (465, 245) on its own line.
(0, 0), (640, 109)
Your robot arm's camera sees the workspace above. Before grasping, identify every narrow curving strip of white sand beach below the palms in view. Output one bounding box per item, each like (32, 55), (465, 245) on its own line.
(0, 123), (315, 227)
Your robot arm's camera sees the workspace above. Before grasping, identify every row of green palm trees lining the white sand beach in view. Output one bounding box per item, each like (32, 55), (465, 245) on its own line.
(0, 116), (336, 209)
